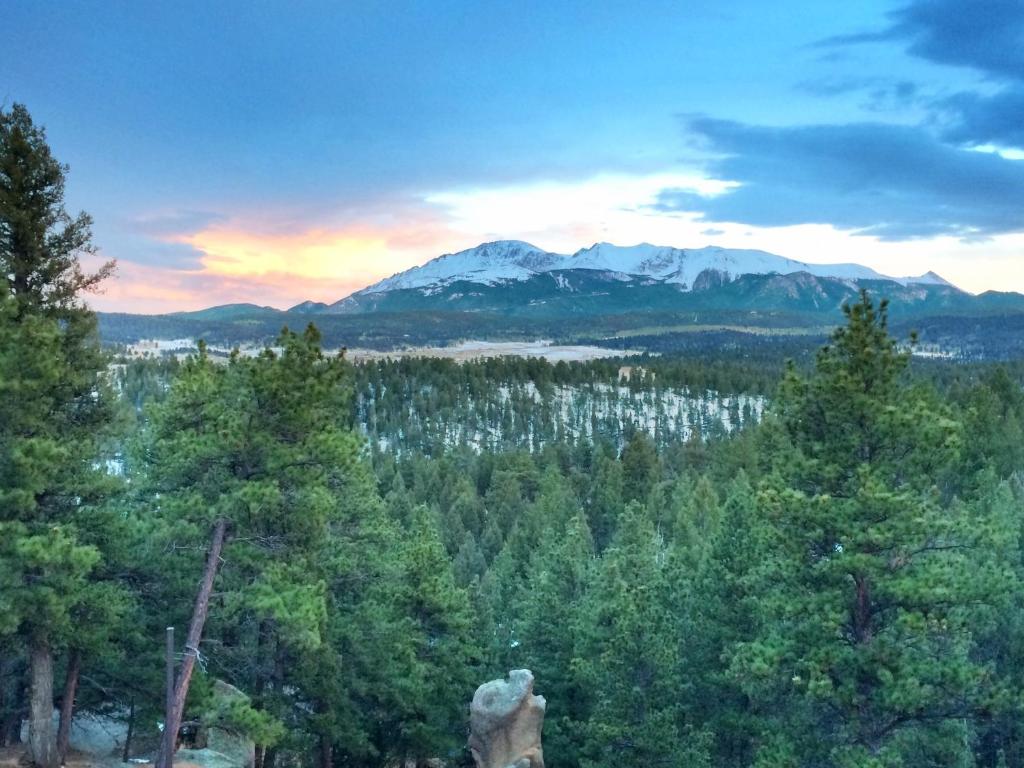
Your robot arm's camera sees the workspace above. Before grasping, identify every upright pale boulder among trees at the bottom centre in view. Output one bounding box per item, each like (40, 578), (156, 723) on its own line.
(469, 670), (547, 768)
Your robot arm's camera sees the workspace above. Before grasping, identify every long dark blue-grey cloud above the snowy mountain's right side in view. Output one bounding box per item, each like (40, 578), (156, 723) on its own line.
(654, 118), (1024, 241)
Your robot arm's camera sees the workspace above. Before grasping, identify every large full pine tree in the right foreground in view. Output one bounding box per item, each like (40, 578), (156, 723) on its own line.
(733, 293), (1013, 766)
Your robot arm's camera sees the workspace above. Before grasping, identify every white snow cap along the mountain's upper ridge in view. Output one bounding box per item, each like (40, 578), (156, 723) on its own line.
(355, 240), (949, 295)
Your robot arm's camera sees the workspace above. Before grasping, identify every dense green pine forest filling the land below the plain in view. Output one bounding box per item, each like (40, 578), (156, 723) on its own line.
(6, 105), (1024, 768)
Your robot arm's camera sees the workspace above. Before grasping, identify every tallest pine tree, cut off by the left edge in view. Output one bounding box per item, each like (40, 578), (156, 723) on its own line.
(0, 104), (113, 768)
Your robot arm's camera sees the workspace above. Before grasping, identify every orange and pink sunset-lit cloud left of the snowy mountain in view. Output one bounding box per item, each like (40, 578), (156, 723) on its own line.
(84, 200), (468, 313)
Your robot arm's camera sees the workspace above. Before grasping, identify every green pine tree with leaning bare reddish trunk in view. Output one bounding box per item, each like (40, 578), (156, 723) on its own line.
(141, 326), (375, 765)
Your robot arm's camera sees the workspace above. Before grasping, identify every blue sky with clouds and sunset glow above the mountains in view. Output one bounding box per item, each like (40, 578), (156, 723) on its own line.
(0, 0), (1024, 313)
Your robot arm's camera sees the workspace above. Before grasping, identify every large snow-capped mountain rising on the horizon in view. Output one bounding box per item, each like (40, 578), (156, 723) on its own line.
(303, 241), (968, 316)
